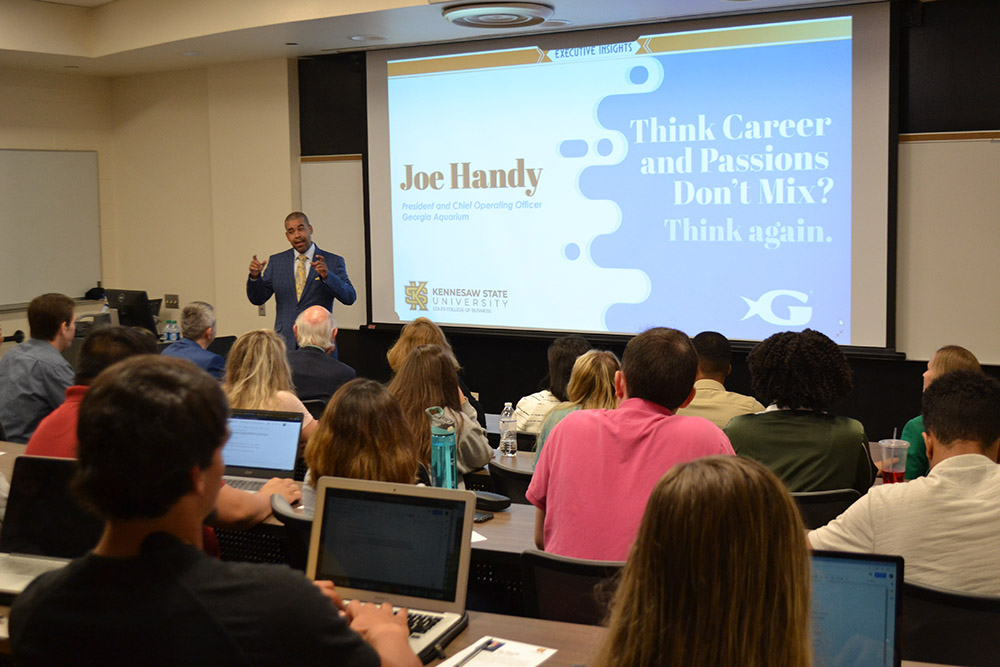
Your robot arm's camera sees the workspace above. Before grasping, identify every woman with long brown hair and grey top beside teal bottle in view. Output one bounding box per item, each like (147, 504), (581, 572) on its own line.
(389, 345), (493, 474)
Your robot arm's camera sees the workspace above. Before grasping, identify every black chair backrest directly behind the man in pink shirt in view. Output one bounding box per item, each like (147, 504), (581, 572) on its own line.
(521, 549), (625, 625)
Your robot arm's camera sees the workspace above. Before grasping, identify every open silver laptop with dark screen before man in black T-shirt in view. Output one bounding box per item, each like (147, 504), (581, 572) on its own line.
(306, 477), (476, 664)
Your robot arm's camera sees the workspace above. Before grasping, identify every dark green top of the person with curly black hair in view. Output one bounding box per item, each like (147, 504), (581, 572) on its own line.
(724, 410), (875, 494)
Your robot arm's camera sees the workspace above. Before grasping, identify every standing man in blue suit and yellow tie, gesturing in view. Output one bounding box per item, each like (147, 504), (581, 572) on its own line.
(247, 211), (358, 350)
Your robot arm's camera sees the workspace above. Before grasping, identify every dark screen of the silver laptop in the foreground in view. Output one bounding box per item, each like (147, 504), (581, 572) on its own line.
(314, 488), (466, 601)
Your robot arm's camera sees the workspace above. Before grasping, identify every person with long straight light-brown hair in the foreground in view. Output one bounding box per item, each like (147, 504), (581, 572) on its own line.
(594, 456), (812, 667)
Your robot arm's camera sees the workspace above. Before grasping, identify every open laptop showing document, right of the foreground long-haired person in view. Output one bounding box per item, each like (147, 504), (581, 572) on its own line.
(812, 551), (903, 667)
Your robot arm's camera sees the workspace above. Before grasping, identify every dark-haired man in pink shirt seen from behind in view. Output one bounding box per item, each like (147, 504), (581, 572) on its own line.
(526, 328), (733, 560)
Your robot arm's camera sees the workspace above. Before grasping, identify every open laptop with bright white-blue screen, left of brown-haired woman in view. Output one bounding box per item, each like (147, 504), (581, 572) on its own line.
(222, 410), (302, 491)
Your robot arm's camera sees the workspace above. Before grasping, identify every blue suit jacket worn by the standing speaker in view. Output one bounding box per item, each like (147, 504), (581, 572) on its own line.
(247, 246), (358, 350)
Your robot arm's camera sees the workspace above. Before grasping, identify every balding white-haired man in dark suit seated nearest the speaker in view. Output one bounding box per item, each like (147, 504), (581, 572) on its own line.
(288, 306), (358, 402)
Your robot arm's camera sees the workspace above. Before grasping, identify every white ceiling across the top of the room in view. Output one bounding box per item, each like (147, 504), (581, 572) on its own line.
(0, 0), (870, 76)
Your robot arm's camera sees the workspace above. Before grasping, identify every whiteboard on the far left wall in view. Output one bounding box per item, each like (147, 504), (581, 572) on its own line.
(0, 150), (101, 305)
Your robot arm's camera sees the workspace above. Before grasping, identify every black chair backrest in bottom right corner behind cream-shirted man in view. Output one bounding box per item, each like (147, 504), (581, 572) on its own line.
(900, 581), (1000, 665)
